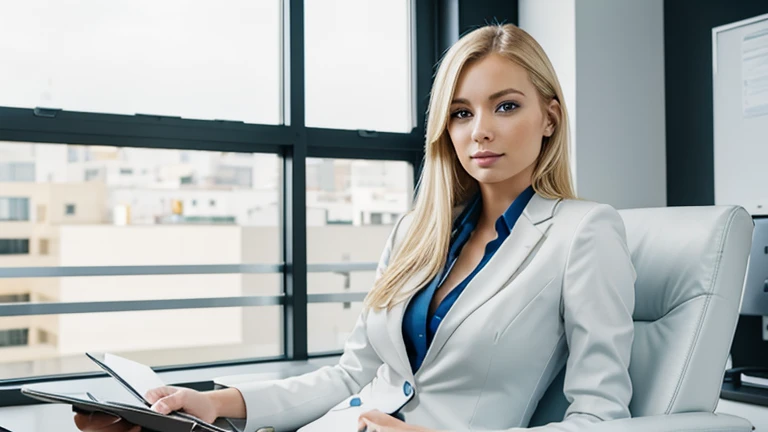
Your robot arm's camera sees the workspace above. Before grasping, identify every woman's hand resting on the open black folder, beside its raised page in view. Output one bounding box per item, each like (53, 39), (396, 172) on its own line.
(144, 387), (218, 423)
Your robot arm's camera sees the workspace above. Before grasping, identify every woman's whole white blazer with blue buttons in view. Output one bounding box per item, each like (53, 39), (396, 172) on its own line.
(235, 194), (636, 432)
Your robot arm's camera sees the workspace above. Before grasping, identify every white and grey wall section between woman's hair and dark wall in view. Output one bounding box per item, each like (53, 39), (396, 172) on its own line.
(519, 0), (667, 208)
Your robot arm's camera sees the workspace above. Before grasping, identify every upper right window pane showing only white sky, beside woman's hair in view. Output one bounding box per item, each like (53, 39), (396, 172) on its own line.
(304, 0), (414, 132)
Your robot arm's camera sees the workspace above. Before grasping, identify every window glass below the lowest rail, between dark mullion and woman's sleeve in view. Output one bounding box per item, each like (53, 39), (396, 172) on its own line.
(307, 302), (363, 353)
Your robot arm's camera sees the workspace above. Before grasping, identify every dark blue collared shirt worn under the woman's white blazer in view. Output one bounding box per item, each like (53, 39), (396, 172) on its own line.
(403, 186), (534, 373)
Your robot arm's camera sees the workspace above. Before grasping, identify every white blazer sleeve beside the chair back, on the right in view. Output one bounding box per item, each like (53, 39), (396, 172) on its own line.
(500, 204), (636, 432)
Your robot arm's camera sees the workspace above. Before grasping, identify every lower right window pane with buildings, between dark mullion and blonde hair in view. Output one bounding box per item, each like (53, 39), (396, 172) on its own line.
(307, 158), (414, 352)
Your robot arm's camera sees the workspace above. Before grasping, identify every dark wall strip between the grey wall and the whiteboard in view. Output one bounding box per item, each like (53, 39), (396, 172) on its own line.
(664, 0), (768, 206)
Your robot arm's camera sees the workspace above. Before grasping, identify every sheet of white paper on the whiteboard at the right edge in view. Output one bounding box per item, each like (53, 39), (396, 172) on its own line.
(741, 29), (768, 118)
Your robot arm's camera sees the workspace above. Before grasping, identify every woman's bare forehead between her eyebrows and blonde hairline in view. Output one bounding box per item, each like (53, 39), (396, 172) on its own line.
(454, 54), (534, 99)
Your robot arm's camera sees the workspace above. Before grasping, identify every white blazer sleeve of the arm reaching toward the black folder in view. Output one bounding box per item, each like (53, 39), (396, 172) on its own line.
(232, 214), (402, 432)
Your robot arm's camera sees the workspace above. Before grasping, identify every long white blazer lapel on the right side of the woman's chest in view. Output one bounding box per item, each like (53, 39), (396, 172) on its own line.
(420, 194), (559, 368)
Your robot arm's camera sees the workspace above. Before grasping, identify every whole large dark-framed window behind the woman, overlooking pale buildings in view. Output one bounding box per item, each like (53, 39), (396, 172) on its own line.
(0, 0), (428, 386)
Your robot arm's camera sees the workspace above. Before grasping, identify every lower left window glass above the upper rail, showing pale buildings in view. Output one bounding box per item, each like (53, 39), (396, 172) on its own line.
(0, 143), (282, 264)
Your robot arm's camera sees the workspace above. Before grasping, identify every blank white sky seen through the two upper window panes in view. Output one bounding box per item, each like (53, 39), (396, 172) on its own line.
(0, 0), (413, 132)
